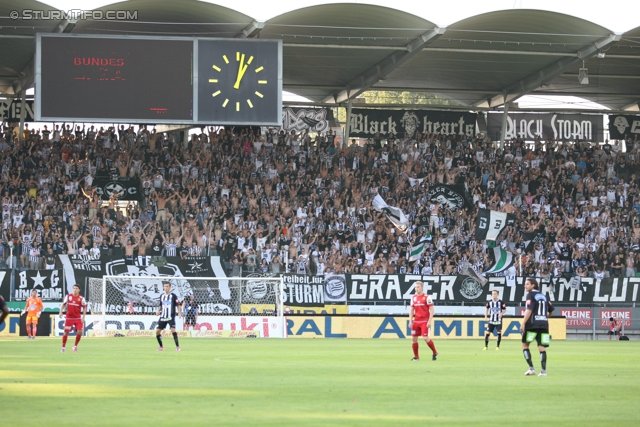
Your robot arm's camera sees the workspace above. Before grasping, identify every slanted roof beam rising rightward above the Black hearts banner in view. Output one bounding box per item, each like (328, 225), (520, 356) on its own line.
(322, 27), (446, 104)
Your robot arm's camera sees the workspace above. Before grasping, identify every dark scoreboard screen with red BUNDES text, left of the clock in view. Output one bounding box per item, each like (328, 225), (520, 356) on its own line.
(36, 36), (193, 123)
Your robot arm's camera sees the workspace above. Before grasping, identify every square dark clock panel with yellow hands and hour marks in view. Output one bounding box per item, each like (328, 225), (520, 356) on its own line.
(198, 40), (282, 125)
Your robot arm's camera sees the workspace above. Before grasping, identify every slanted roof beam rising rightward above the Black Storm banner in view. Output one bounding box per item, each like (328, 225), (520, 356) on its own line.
(476, 34), (622, 108)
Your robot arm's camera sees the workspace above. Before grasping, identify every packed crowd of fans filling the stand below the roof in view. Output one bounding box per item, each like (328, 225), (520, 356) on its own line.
(0, 118), (640, 278)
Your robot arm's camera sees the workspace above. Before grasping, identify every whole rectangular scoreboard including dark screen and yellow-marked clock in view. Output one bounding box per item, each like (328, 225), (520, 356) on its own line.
(35, 34), (282, 126)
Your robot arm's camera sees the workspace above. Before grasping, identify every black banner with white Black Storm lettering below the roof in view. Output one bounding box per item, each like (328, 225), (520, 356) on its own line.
(487, 112), (604, 141)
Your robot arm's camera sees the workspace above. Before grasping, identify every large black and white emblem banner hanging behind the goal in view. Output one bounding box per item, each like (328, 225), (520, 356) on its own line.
(58, 255), (235, 314)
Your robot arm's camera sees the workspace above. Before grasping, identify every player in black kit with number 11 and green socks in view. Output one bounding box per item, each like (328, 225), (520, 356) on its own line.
(520, 279), (553, 377)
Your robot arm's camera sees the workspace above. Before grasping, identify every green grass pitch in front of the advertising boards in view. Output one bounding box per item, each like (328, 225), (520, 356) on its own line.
(0, 338), (640, 426)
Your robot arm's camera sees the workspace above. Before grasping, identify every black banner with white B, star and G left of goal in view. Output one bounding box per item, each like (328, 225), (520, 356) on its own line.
(13, 270), (67, 302)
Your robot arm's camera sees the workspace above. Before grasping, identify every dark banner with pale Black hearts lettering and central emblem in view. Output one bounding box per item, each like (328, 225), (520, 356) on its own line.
(349, 108), (477, 138)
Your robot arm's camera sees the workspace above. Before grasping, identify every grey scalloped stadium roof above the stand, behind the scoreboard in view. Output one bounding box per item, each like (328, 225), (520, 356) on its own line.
(0, 0), (640, 112)
